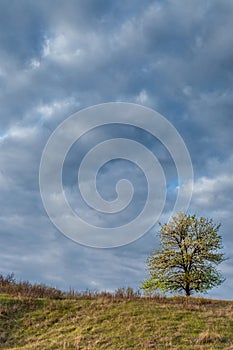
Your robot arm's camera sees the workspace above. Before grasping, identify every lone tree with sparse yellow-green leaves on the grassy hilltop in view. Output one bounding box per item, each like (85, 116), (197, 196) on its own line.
(142, 213), (226, 296)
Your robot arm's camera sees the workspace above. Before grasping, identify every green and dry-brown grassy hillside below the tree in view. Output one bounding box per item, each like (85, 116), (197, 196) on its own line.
(0, 294), (233, 350)
